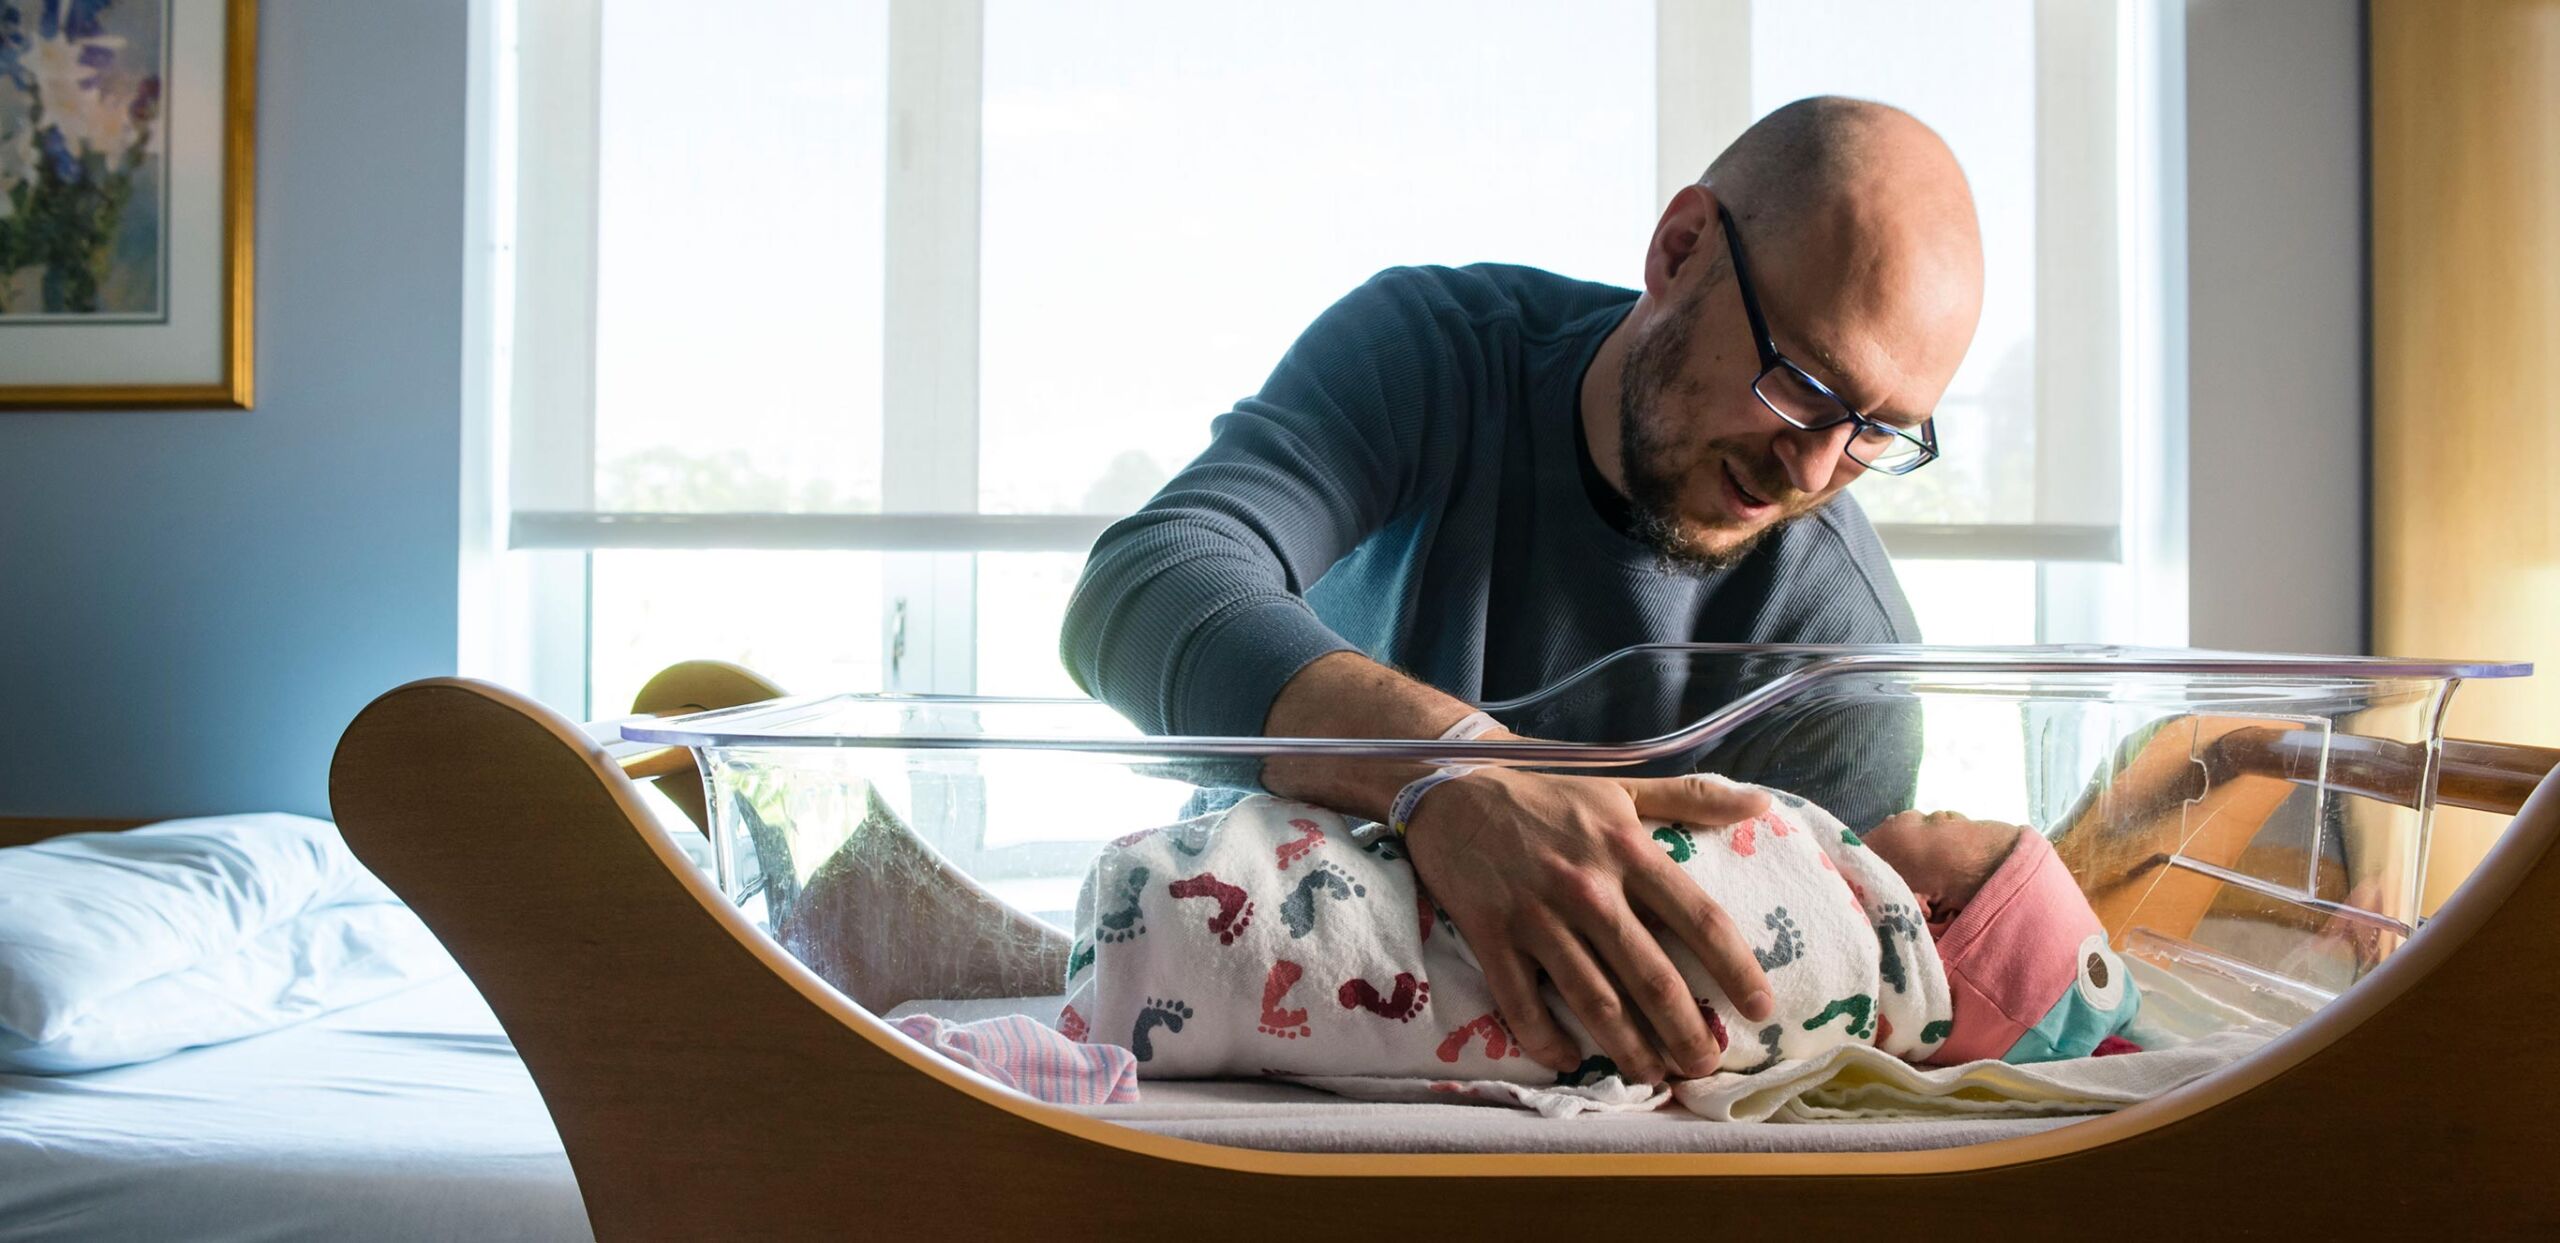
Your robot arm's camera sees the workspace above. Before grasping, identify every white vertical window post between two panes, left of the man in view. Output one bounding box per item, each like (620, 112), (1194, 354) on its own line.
(881, 0), (986, 693)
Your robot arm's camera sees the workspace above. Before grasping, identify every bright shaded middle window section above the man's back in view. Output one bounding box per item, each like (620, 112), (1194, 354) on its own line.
(978, 0), (1656, 514)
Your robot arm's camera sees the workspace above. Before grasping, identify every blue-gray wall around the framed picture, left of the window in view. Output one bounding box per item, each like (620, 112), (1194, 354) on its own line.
(0, 0), (468, 816)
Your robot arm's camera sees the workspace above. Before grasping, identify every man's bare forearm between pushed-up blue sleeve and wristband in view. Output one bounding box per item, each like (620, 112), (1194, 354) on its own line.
(1262, 652), (1503, 821)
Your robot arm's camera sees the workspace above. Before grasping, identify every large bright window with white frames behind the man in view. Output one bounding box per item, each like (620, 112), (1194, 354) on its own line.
(479, 0), (2184, 714)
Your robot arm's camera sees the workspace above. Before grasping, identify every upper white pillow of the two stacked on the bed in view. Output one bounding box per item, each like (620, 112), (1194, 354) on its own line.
(0, 813), (394, 1044)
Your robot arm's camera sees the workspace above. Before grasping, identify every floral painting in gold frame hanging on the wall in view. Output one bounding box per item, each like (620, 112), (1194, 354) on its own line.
(0, 0), (259, 409)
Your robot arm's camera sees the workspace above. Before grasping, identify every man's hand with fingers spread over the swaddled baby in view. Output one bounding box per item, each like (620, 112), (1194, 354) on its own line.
(1405, 767), (1774, 1082)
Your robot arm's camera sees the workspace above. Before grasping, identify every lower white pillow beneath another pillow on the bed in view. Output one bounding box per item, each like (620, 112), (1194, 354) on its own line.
(0, 903), (456, 1074)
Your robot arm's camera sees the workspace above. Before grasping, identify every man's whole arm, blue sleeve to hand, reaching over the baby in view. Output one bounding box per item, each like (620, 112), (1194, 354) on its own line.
(1060, 271), (1769, 1079)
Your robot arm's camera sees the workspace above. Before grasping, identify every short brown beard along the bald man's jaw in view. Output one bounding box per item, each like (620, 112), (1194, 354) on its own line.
(1618, 289), (1810, 578)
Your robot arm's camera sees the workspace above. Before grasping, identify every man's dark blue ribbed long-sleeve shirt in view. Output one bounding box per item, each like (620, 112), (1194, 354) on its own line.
(1060, 263), (1920, 813)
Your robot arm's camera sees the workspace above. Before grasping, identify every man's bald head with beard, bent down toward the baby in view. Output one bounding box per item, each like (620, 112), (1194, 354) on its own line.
(1597, 97), (1981, 578)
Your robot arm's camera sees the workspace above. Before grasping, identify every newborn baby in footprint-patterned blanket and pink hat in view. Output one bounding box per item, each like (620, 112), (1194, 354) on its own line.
(1060, 778), (2140, 1095)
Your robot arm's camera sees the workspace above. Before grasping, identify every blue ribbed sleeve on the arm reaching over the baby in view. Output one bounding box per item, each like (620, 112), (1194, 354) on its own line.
(1060, 269), (1472, 737)
